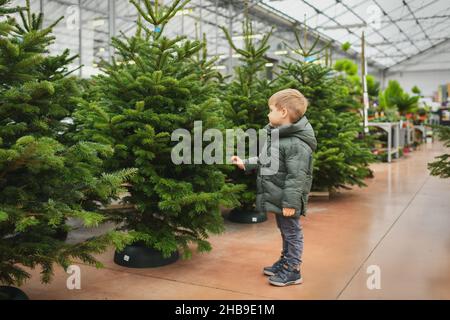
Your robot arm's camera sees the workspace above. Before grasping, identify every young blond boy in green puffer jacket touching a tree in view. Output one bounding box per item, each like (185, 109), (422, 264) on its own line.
(231, 89), (317, 286)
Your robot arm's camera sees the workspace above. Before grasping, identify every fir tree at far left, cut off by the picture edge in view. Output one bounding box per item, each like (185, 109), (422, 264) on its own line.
(0, 1), (132, 285)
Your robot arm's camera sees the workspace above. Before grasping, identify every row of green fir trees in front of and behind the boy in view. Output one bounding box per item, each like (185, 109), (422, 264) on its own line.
(0, 0), (372, 292)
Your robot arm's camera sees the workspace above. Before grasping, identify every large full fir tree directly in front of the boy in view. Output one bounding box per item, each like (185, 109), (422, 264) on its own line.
(76, 0), (241, 258)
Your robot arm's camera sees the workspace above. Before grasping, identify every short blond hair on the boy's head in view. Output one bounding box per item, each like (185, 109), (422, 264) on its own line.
(269, 89), (308, 123)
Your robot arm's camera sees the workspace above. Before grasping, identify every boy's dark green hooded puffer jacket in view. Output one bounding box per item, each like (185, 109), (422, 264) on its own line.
(244, 117), (317, 218)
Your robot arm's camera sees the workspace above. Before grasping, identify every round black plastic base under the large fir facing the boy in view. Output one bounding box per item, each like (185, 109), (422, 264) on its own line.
(114, 244), (180, 268)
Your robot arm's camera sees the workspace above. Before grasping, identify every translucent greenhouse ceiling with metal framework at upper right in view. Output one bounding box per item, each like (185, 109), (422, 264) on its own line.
(260, 0), (450, 68)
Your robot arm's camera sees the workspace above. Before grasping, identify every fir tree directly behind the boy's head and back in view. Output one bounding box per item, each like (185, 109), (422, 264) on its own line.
(278, 30), (373, 191)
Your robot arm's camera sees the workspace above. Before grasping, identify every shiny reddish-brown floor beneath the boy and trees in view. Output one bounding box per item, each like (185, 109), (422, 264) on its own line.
(22, 143), (450, 299)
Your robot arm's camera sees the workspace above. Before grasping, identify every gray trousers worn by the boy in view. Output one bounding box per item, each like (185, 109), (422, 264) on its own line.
(275, 214), (303, 267)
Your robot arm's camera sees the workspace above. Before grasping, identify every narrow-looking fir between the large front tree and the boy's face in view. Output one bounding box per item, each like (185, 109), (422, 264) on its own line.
(222, 14), (275, 214)
